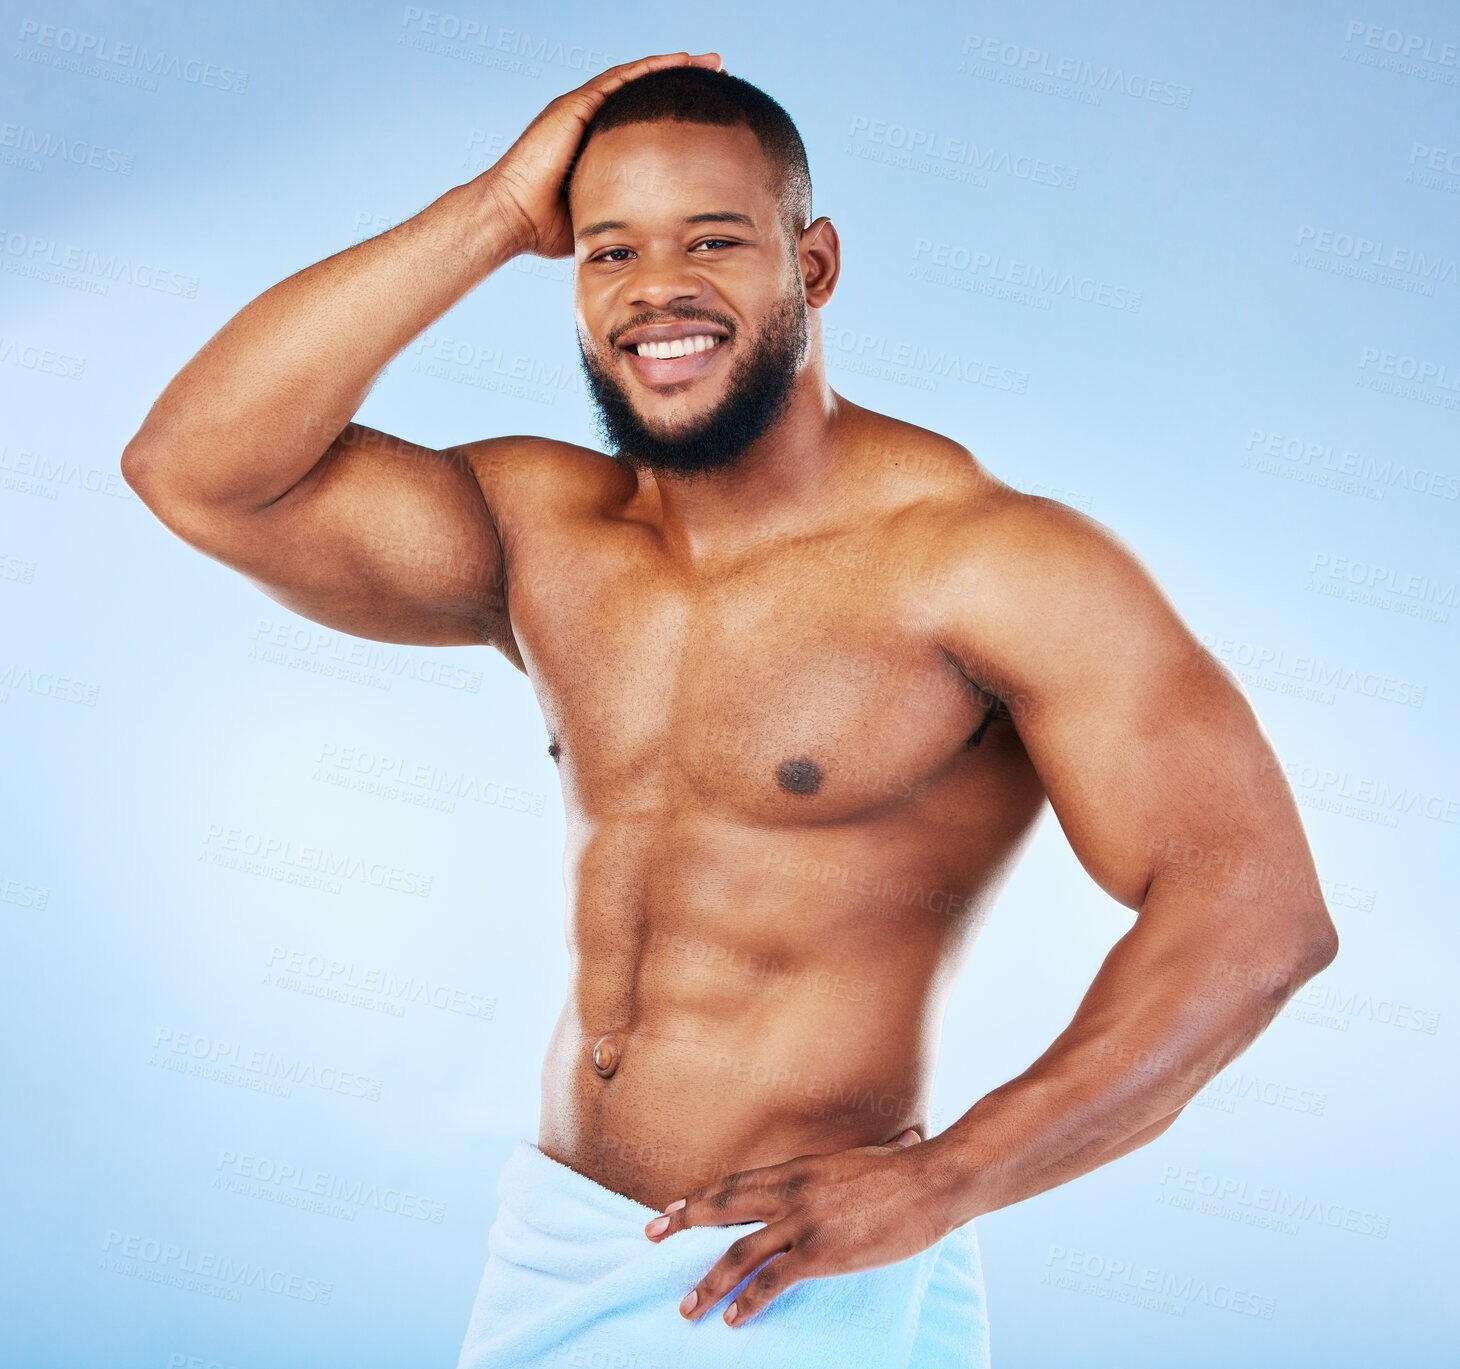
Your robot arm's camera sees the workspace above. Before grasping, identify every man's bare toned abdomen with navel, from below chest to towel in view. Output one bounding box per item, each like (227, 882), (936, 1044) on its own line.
(539, 825), (1004, 1207)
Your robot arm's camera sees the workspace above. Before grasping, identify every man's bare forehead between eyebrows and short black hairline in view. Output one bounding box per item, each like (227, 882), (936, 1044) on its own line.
(568, 120), (775, 229)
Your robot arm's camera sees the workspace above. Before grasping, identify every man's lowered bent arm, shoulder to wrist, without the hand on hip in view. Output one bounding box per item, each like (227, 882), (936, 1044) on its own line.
(923, 498), (1337, 1222)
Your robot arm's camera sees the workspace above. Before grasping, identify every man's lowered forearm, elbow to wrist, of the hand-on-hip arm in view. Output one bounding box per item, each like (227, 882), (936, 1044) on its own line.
(929, 886), (1327, 1223)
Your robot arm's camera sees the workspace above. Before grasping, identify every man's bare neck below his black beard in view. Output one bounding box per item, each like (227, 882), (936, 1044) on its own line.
(638, 356), (848, 558)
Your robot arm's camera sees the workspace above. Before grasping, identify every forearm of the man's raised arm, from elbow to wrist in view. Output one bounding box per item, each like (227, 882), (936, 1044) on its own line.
(124, 171), (520, 508)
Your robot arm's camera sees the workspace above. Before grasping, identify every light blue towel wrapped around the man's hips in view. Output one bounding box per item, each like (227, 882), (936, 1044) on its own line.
(457, 1141), (988, 1369)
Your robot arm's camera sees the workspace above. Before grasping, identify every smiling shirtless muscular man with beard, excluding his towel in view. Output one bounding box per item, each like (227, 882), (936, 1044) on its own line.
(123, 53), (1337, 1340)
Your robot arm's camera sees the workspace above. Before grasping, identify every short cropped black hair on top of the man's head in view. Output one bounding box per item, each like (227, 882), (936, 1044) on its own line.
(562, 66), (812, 248)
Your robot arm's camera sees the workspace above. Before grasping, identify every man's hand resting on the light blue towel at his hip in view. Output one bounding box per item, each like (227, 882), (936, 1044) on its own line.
(644, 1128), (952, 1327)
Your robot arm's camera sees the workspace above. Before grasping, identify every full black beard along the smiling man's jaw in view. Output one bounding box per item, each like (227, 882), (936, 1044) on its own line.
(578, 295), (806, 476)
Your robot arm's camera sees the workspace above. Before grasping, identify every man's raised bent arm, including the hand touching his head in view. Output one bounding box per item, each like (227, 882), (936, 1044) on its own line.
(121, 53), (718, 658)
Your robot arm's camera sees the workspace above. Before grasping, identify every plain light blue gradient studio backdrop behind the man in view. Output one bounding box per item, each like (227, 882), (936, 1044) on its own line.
(0, 0), (1460, 1369)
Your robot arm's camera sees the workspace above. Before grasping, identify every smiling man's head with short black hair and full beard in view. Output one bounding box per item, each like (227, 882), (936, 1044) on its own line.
(565, 67), (835, 476)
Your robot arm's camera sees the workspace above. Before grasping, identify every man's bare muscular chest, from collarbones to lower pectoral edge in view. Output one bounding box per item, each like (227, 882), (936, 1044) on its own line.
(511, 540), (987, 823)
